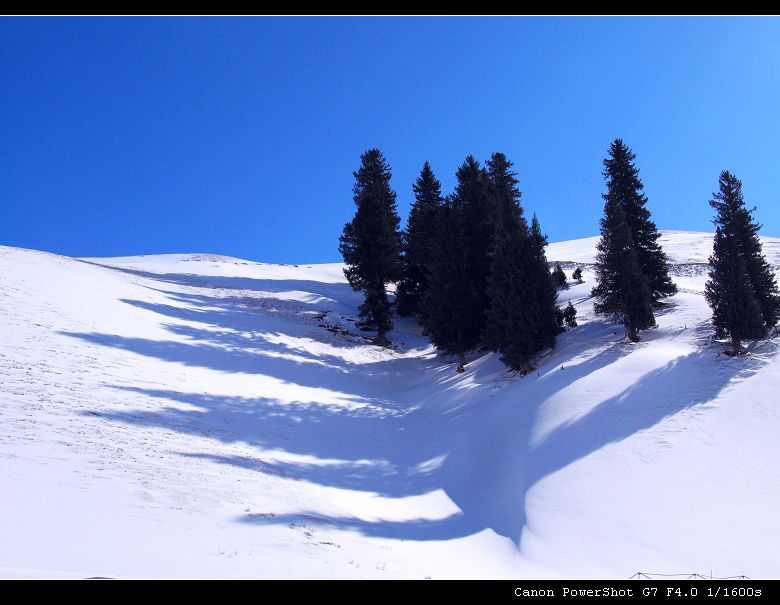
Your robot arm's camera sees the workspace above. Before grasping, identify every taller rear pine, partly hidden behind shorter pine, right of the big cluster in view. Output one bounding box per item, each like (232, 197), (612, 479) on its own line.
(603, 139), (677, 303)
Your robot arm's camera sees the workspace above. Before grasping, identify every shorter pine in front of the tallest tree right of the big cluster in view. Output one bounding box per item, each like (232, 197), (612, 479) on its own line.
(592, 197), (655, 342)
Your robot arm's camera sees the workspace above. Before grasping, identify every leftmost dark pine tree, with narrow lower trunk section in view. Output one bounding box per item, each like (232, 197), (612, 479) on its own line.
(339, 149), (401, 346)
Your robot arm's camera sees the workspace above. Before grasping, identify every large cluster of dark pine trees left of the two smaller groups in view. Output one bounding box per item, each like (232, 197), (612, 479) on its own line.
(339, 149), (564, 372)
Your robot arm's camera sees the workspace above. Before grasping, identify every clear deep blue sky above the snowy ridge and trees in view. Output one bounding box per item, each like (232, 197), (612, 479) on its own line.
(0, 18), (780, 262)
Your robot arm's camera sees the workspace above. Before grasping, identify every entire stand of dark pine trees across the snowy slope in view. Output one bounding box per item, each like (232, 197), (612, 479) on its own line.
(339, 139), (780, 373)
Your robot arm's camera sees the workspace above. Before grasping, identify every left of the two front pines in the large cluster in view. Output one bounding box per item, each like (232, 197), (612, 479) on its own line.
(422, 197), (484, 372)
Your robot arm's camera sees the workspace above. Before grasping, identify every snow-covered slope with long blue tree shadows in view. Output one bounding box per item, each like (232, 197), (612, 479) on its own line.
(0, 232), (780, 578)
